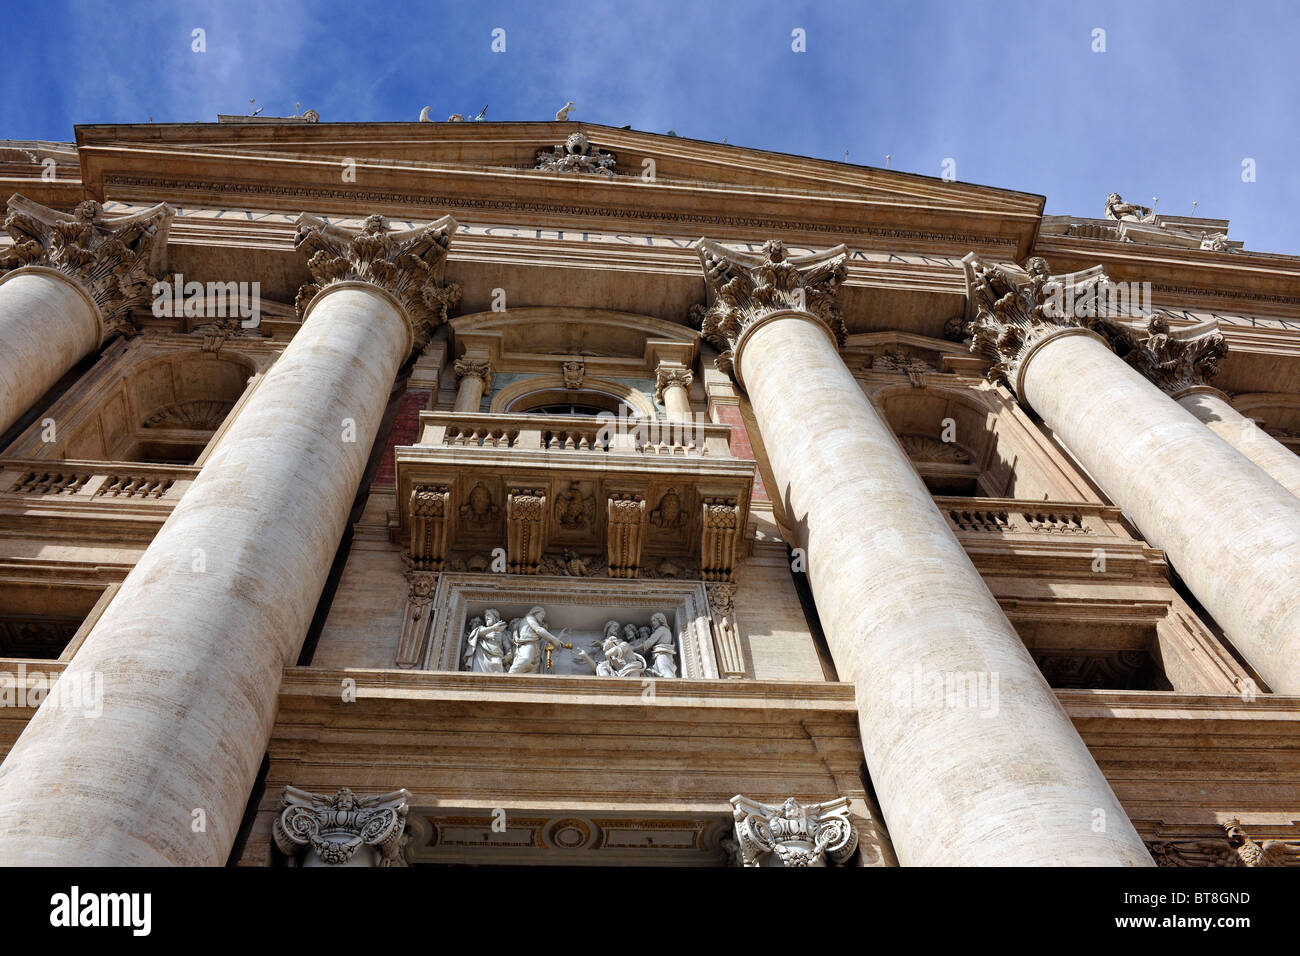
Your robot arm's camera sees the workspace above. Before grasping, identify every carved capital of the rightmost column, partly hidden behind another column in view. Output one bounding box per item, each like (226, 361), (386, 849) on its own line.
(1112, 312), (1227, 398)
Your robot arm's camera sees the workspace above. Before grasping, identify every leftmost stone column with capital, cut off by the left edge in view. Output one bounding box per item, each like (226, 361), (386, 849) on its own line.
(0, 195), (173, 432)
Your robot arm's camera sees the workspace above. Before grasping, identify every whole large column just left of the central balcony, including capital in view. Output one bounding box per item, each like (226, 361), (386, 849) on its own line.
(0, 216), (459, 866)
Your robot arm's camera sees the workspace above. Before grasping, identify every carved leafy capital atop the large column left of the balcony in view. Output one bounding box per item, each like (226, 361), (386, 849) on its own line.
(294, 213), (460, 351)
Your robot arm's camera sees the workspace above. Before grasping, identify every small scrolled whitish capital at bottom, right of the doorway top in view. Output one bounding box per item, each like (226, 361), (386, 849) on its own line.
(731, 796), (858, 866)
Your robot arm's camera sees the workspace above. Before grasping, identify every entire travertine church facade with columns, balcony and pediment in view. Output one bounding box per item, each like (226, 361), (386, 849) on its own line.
(0, 121), (1300, 866)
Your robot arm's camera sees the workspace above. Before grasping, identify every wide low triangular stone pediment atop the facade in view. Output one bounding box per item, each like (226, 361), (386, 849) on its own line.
(77, 122), (1044, 255)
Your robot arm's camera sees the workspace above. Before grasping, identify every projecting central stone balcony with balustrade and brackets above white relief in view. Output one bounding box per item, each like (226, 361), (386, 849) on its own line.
(393, 411), (754, 581)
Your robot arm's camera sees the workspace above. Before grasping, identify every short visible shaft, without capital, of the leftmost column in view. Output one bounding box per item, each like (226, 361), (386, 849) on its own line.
(0, 265), (100, 432)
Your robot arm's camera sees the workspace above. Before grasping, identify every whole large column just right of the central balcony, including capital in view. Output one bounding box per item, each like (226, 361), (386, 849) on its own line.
(699, 241), (1151, 865)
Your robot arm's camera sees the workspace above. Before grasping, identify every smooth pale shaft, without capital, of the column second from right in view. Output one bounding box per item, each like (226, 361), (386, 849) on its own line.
(1021, 329), (1300, 693)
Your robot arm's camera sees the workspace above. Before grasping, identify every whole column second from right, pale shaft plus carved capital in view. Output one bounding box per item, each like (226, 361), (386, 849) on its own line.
(966, 256), (1300, 693)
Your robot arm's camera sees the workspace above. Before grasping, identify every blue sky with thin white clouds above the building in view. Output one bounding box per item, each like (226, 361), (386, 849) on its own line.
(0, 0), (1300, 254)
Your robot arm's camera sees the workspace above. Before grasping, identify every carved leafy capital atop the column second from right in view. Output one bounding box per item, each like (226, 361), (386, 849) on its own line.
(948, 252), (1112, 393)
